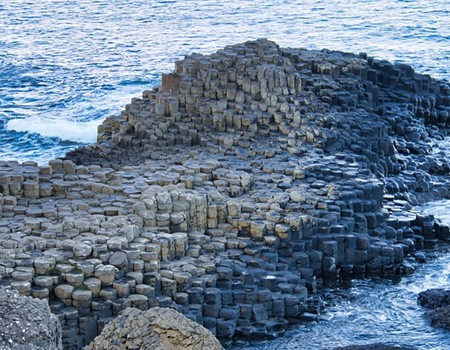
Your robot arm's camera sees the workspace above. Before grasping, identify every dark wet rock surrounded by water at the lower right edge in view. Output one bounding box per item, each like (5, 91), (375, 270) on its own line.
(418, 288), (450, 331)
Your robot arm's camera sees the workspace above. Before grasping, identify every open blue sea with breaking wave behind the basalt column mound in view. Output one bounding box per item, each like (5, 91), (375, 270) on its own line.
(0, 0), (450, 160)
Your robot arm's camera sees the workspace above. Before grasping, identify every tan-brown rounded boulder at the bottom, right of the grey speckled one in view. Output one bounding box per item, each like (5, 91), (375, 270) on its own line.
(85, 308), (223, 350)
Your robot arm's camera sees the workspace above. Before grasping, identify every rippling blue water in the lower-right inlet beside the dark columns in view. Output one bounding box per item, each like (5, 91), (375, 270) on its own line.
(236, 200), (450, 350)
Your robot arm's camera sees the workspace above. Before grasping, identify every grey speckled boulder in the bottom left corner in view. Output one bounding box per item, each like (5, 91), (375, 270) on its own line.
(0, 288), (62, 350)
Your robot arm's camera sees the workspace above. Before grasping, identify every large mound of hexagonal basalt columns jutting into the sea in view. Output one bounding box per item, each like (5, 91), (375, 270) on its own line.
(0, 39), (450, 349)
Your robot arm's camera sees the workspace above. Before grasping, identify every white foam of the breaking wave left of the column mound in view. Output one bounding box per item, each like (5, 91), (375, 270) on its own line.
(6, 117), (102, 143)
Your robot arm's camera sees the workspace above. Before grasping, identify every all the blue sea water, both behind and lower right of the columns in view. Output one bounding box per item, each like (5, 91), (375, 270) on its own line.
(0, 0), (450, 350)
